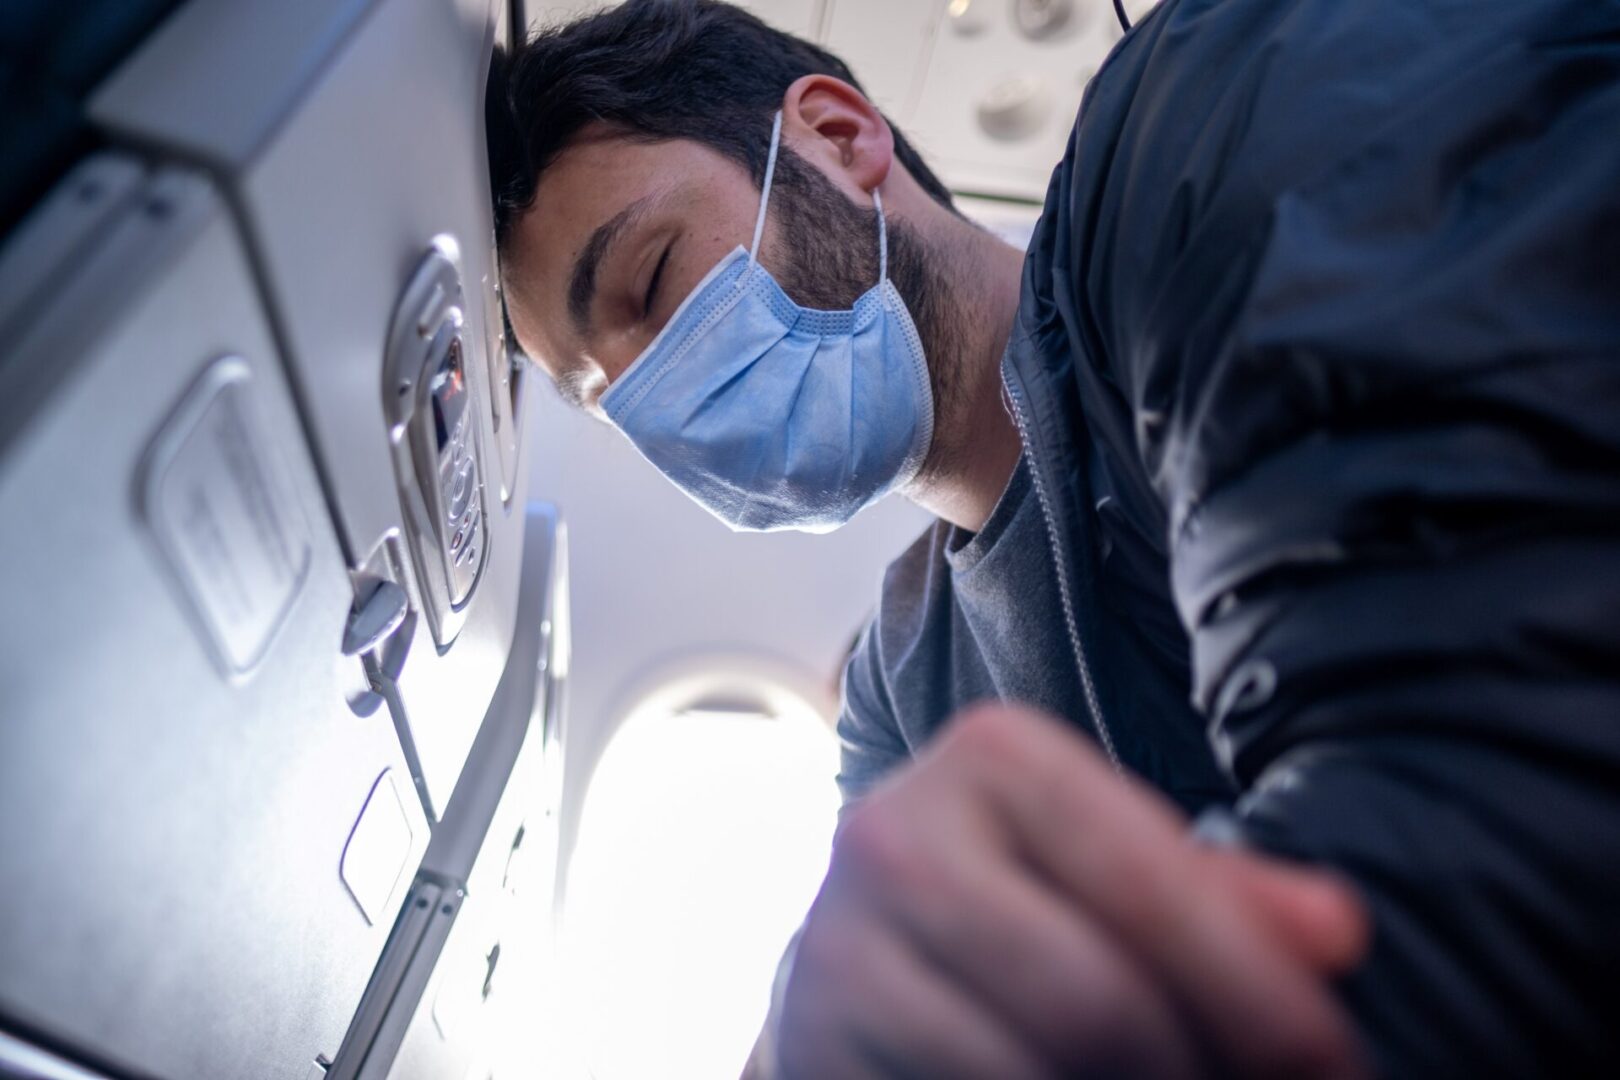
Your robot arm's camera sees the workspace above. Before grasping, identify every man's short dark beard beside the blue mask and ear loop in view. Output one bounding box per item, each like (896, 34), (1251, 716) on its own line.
(771, 146), (969, 483)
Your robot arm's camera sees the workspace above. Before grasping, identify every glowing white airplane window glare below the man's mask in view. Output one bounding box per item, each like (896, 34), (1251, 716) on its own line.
(562, 702), (838, 1080)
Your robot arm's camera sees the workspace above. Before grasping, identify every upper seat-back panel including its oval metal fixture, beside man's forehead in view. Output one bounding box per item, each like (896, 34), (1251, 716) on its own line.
(91, 0), (523, 819)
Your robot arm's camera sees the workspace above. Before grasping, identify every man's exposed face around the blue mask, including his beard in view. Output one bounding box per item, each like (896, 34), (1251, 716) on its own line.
(502, 118), (969, 488)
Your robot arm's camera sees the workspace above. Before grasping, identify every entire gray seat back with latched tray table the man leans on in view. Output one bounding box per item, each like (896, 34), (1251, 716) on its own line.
(0, 0), (561, 1080)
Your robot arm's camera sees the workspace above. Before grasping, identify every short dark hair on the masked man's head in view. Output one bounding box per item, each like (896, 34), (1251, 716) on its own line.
(486, 0), (951, 244)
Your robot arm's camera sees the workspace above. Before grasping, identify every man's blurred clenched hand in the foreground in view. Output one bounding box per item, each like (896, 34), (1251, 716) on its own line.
(774, 706), (1366, 1080)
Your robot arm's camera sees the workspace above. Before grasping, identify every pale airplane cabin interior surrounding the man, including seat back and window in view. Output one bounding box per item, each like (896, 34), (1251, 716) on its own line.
(0, 0), (1150, 1080)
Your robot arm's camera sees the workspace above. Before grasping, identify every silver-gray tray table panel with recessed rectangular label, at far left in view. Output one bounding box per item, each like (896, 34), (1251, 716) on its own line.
(0, 170), (428, 1080)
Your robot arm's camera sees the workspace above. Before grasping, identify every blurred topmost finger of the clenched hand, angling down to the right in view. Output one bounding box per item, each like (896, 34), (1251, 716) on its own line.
(941, 708), (1362, 1077)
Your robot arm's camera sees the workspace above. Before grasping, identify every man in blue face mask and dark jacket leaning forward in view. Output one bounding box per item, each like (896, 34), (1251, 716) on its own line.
(491, 0), (1620, 1078)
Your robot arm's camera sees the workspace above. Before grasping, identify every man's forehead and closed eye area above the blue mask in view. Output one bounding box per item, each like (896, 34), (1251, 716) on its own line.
(505, 128), (774, 408)
